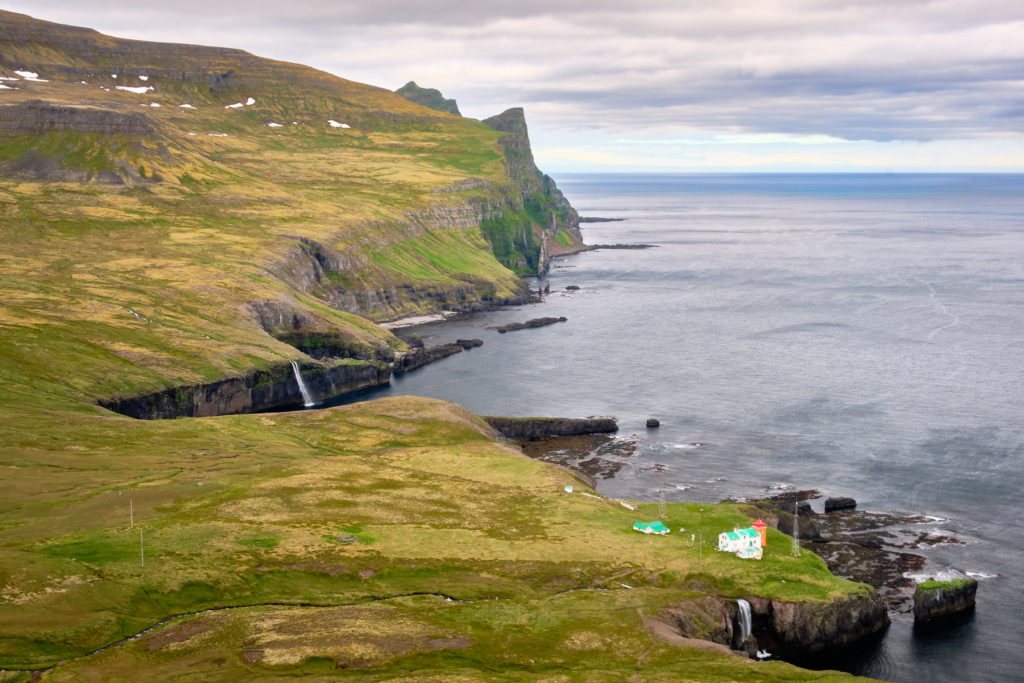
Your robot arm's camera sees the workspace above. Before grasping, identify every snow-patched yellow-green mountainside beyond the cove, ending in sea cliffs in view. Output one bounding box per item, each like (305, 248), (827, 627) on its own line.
(0, 11), (567, 409)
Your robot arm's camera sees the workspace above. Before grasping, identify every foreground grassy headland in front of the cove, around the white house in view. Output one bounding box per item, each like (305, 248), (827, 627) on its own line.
(0, 398), (868, 680)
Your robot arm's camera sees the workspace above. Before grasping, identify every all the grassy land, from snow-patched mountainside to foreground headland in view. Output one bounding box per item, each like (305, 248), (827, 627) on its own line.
(0, 12), (880, 681)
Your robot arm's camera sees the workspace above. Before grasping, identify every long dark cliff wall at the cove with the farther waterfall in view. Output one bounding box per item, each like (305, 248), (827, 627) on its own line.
(99, 360), (391, 420)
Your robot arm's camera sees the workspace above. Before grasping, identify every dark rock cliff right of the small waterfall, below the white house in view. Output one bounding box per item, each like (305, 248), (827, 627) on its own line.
(746, 587), (889, 659)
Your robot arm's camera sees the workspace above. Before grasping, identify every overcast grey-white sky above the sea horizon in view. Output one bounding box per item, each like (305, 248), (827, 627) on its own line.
(8, 0), (1024, 173)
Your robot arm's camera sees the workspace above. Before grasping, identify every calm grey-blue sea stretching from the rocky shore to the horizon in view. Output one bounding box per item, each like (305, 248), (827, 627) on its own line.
(331, 175), (1024, 682)
